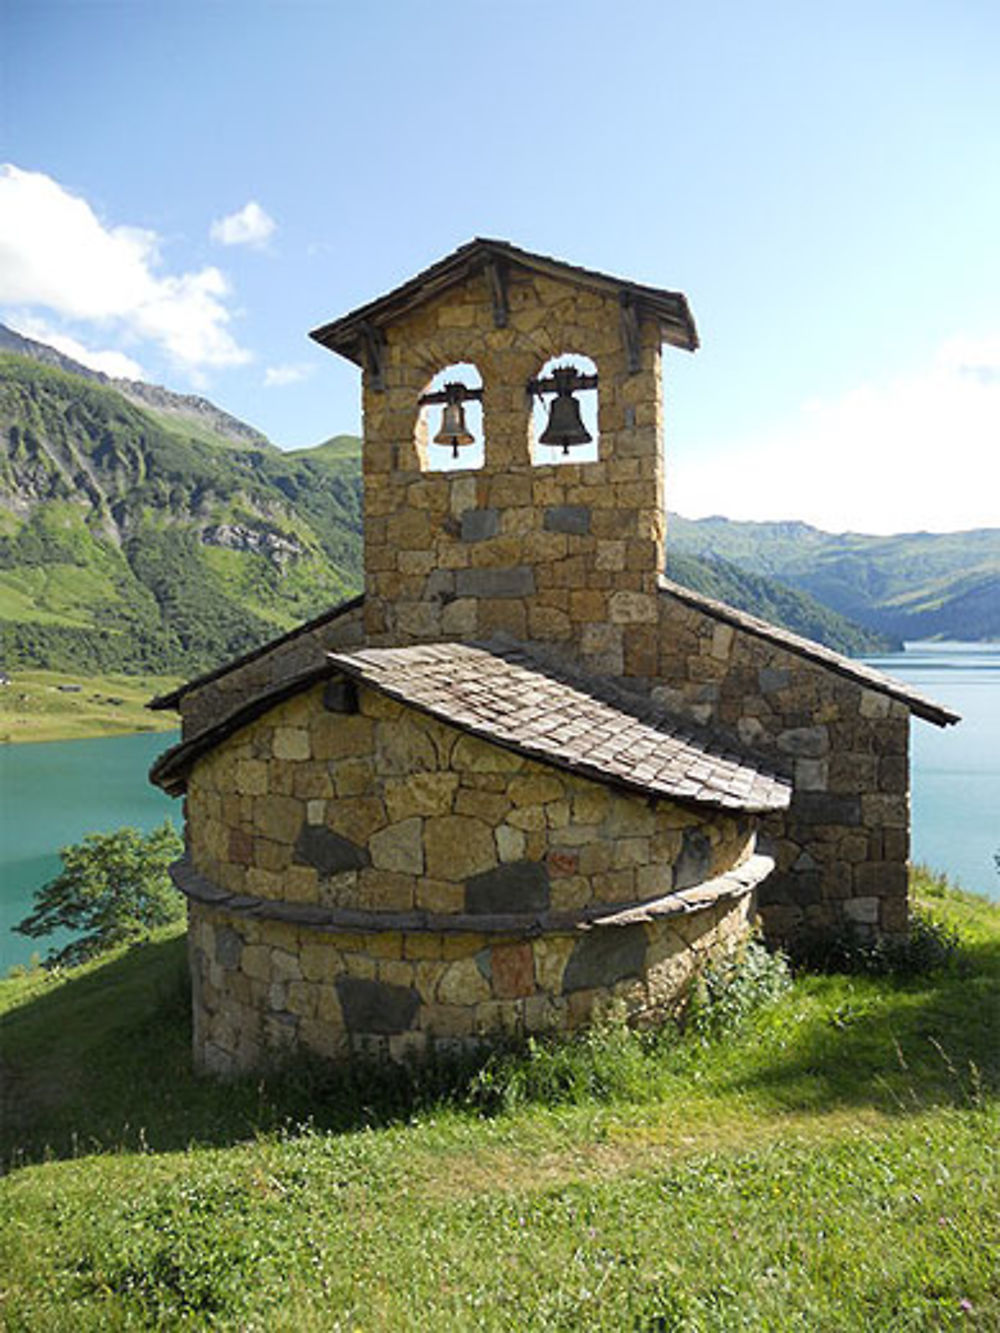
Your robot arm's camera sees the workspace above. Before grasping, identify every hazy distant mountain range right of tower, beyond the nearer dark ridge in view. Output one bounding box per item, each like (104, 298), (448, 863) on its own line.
(669, 515), (1000, 640)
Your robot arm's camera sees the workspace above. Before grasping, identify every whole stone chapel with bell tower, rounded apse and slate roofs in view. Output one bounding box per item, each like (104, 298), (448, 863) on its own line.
(151, 239), (957, 1074)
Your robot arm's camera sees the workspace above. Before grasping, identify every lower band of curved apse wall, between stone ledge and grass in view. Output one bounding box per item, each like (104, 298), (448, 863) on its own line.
(188, 893), (753, 1074)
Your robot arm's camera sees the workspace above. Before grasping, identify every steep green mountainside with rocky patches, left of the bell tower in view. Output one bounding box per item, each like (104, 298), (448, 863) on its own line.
(0, 355), (361, 672)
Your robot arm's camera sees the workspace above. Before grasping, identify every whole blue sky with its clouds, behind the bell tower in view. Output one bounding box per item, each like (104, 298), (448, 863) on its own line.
(0, 0), (1000, 532)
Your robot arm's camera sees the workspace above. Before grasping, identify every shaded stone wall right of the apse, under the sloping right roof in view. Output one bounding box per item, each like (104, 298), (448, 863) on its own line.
(648, 591), (909, 941)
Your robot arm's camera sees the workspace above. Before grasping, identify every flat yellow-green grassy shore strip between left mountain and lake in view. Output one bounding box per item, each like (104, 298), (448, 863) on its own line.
(0, 669), (180, 745)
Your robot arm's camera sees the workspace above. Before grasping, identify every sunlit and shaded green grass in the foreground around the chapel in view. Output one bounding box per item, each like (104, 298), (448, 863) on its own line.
(0, 876), (1000, 1333)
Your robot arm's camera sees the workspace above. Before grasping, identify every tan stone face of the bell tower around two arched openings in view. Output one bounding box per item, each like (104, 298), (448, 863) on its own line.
(364, 267), (664, 676)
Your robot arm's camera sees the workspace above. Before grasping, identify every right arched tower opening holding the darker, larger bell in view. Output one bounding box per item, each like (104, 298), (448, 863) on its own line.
(528, 352), (600, 465)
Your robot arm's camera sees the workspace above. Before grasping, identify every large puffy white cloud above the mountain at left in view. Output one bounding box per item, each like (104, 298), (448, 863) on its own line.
(0, 164), (251, 372)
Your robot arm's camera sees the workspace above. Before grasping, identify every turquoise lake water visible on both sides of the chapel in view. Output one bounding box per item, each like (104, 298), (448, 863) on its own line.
(0, 644), (1000, 976)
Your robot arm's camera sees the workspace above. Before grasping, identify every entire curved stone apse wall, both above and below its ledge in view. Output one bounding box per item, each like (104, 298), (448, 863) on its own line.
(180, 685), (755, 1073)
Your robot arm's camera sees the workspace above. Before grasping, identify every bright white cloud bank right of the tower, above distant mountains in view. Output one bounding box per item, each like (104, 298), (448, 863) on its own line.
(668, 337), (1000, 533)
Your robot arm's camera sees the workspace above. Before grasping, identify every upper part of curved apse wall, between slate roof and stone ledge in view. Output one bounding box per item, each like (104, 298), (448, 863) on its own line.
(187, 685), (756, 914)
